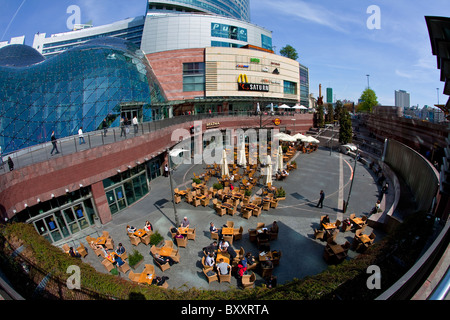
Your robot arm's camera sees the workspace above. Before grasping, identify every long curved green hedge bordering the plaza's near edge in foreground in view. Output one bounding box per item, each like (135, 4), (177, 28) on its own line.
(1, 213), (433, 300)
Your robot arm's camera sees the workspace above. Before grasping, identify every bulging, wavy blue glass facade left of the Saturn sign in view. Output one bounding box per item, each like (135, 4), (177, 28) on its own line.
(0, 38), (166, 152)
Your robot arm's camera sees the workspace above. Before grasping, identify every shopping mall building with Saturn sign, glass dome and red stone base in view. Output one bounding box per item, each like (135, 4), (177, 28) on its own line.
(0, 0), (313, 243)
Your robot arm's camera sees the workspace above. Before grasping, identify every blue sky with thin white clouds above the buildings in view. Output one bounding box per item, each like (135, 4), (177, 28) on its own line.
(0, 0), (450, 107)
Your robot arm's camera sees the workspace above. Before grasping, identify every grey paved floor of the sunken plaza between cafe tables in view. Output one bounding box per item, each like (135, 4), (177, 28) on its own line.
(80, 147), (383, 290)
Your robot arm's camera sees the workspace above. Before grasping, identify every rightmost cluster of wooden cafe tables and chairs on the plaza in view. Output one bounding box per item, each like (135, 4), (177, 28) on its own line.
(314, 213), (376, 264)
